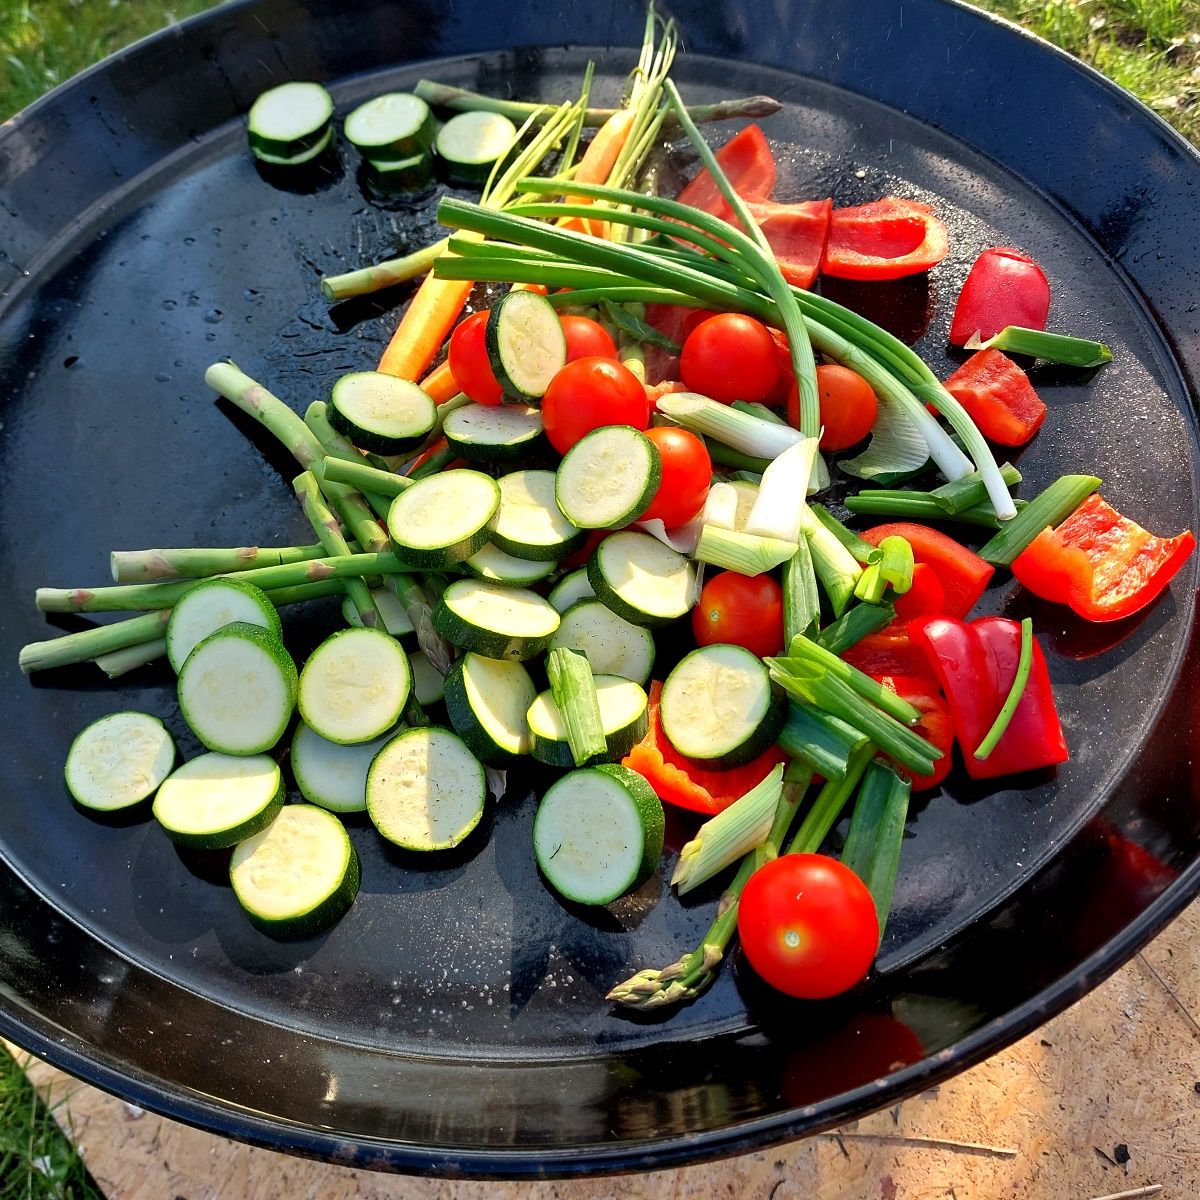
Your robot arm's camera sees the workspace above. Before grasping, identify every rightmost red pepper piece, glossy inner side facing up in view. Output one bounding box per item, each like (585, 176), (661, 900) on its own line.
(1013, 492), (1196, 620)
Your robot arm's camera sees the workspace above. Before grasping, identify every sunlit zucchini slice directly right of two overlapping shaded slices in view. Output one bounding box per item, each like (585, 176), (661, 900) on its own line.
(298, 629), (413, 745)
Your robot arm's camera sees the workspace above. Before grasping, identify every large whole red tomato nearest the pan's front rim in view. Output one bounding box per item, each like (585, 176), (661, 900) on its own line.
(738, 854), (880, 1000)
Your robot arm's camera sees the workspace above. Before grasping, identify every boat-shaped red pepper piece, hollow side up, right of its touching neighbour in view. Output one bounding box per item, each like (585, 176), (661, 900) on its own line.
(821, 196), (949, 280)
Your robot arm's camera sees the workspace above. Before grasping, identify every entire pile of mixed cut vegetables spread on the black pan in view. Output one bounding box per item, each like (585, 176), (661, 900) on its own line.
(20, 10), (1194, 1007)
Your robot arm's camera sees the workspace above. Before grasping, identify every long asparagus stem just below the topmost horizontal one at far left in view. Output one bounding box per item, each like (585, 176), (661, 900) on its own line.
(36, 553), (409, 614)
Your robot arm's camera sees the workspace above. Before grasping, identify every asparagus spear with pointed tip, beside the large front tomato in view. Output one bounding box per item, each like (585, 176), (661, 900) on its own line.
(607, 764), (812, 1008)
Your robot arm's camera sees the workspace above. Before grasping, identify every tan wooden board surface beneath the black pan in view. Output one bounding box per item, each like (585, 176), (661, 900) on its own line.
(11, 901), (1200, 1200)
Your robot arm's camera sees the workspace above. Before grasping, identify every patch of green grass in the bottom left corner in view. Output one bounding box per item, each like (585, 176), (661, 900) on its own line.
(0, 1044), (104, 1200)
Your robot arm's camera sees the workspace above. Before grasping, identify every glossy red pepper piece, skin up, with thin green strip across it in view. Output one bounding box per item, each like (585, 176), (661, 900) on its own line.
(908, 617), (1067, 779)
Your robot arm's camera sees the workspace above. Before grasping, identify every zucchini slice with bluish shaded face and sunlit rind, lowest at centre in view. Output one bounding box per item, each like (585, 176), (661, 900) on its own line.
(533, 763), (666, 904)
